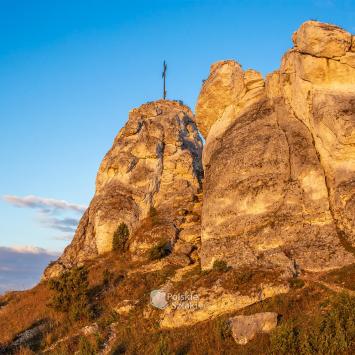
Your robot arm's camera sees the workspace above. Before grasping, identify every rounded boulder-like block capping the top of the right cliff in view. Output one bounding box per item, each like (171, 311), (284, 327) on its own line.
(292, 21), (351, 58)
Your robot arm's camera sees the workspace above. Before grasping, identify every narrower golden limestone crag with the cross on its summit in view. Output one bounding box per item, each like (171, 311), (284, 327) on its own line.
(45, 100), (203, 277)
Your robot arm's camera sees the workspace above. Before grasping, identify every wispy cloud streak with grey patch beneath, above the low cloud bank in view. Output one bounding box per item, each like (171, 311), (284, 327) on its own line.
(3, 195), (86, 240)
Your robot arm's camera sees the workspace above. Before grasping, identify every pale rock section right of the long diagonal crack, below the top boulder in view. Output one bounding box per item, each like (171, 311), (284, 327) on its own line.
(280, 22), (355, 244)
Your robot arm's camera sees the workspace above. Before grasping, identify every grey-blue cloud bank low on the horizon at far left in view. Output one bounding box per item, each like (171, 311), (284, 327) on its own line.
(0, 245), (59, 294)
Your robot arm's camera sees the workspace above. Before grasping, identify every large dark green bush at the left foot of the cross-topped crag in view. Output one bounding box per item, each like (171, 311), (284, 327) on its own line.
(49, 267), (92, 320)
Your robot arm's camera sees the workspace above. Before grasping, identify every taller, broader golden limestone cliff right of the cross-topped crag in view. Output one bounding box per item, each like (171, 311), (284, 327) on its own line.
(196, 21), (355, 274)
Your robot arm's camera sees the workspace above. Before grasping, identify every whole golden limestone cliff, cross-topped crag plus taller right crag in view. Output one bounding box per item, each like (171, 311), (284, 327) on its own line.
(45, 21), (355, 284)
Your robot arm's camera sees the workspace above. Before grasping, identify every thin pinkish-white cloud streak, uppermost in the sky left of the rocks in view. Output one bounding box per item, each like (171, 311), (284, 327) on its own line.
(3, 195), (86, 213)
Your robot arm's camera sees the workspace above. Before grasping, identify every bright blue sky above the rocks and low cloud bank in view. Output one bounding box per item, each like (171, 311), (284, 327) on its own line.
(0, 0), (355, 264)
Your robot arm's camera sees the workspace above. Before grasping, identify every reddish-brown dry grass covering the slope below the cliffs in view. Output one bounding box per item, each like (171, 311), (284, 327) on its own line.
(0, 253), (355, 355)
